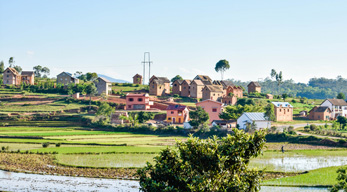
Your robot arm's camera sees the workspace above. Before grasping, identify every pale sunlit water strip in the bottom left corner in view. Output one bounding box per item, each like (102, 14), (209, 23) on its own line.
(0, 170), (139, 192)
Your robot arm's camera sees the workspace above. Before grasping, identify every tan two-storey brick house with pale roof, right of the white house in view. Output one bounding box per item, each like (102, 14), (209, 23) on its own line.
(272, 102), (293, 121)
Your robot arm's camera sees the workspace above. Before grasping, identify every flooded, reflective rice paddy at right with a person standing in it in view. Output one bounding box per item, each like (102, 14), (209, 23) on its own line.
(251, 156), (347, 172)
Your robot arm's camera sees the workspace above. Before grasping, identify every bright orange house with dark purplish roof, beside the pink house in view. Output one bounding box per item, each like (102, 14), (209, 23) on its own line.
(166, 105), (189, 124)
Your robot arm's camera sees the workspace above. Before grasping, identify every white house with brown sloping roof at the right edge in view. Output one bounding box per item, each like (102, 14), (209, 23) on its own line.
(320, 99), (347, 119)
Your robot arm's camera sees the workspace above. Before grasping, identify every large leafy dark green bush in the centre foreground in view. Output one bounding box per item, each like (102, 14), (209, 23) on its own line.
(138, 129), (265, 192)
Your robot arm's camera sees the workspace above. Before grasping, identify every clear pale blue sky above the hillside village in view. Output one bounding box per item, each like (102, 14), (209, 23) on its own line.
(0, 0), (347, 82)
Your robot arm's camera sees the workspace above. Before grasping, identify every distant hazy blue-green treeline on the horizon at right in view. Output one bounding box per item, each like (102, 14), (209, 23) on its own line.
(231, 76), (347, 99)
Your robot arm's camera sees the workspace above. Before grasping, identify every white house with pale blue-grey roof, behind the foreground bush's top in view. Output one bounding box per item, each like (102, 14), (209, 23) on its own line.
(237, 113), (271, 129)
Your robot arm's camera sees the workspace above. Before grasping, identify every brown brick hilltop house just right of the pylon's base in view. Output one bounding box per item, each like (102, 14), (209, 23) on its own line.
(149, 75), (170, 96)
